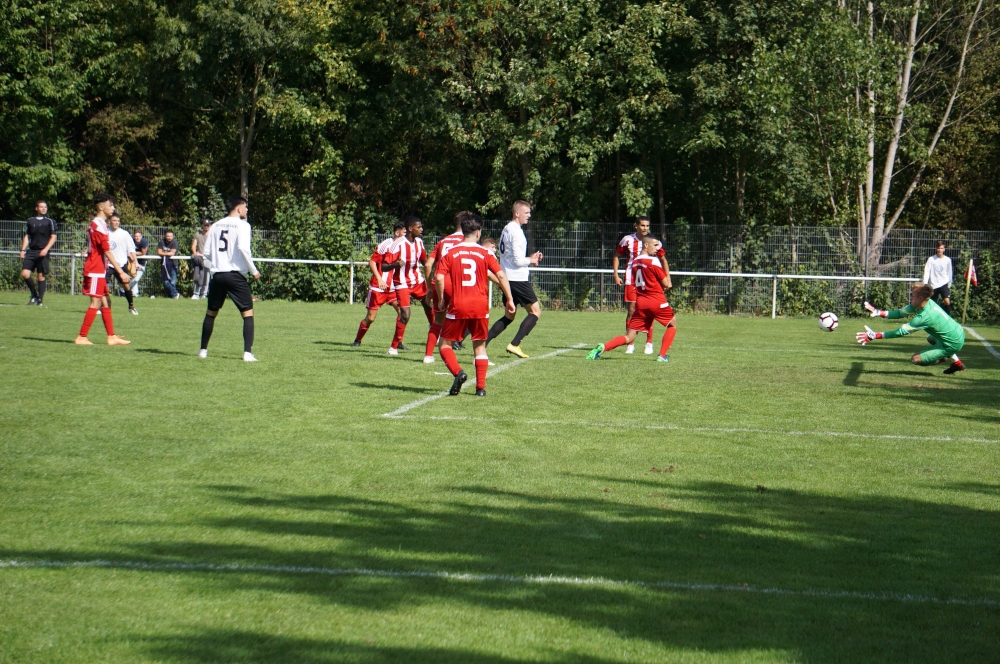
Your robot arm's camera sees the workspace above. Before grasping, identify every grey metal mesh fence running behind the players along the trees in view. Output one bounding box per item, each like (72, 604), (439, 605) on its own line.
(0, 220), (1000, 315)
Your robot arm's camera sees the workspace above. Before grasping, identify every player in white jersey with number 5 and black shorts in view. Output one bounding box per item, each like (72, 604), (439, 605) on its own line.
(198, 196), (260, 362)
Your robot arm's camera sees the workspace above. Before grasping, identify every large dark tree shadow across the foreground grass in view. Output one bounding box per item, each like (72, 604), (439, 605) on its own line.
(9, 482), (1000, 664)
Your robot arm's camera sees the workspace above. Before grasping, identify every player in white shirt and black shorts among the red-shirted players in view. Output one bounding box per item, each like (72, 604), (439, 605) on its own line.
(486, 201), (542, 358)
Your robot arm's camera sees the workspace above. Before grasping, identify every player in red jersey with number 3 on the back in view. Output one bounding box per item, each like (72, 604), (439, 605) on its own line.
(434, 214), (517, 397)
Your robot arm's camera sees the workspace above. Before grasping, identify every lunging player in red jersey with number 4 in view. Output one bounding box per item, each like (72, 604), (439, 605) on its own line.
(587, 235), (677, 362)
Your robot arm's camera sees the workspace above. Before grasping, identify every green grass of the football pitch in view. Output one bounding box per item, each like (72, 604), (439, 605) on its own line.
(0, 293), (1000, 664)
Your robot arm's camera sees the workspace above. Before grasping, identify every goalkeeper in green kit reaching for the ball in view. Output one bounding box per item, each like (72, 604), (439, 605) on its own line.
(858, 284), (965, 374)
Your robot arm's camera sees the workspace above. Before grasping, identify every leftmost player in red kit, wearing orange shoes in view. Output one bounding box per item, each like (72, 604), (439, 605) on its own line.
(73, 194), (132, 346)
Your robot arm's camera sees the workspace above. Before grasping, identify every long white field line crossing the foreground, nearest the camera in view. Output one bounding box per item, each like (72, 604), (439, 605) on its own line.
(0, 560), (1000, 606)
